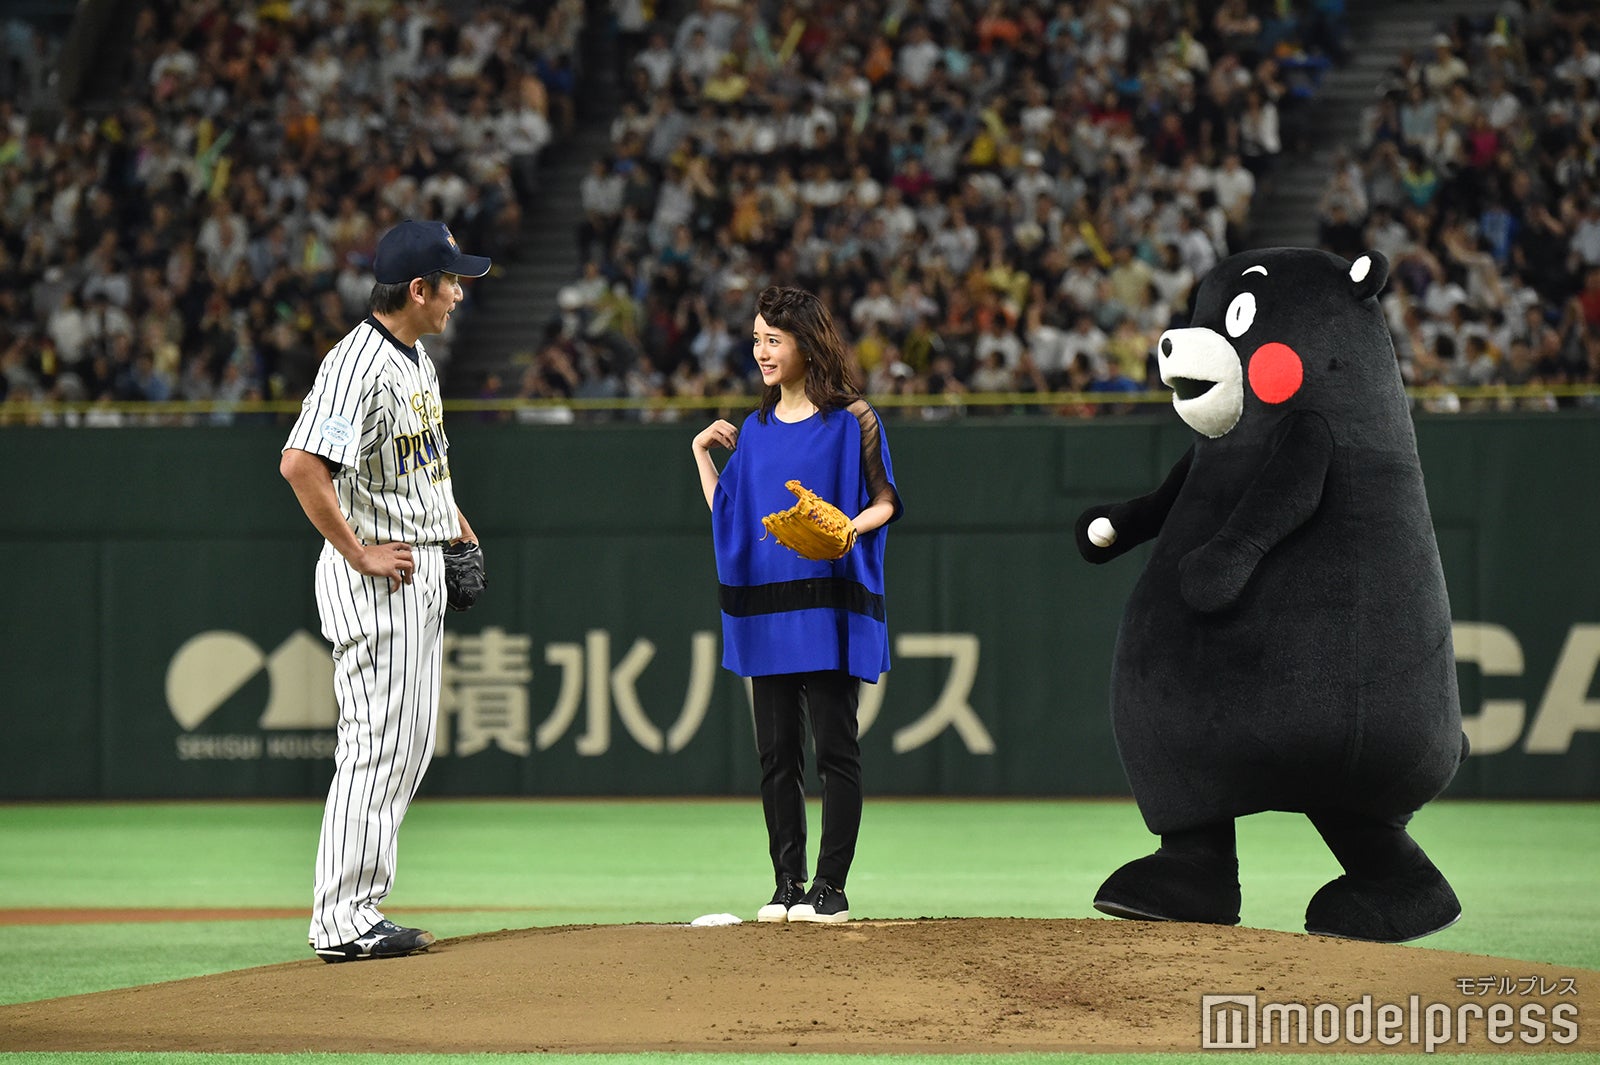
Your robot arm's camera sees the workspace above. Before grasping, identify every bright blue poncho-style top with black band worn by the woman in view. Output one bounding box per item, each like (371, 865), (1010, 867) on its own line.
(712, 400), (901, 681)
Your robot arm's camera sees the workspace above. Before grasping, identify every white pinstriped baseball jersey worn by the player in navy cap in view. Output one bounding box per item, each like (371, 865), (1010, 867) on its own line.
(285, 318), (461, 544)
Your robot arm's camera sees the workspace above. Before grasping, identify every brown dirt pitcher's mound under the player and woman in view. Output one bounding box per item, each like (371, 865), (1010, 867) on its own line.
(0, 918), (1600, 1054)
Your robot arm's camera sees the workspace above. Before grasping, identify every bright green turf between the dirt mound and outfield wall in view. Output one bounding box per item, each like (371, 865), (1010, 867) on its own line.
(0, 800), (1600, 1065)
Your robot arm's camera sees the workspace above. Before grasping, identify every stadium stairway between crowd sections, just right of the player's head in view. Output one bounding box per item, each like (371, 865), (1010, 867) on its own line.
(446, 0), (622, 397)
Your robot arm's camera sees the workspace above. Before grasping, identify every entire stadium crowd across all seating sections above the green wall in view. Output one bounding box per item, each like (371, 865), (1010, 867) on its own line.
(0, 0), (1600, 424)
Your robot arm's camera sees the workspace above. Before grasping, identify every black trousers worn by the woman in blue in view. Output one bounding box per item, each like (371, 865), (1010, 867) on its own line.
(750, 670), (861, 888)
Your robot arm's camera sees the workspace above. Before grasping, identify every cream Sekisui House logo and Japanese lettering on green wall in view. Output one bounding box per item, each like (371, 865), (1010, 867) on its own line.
(166, 625), (995, 761)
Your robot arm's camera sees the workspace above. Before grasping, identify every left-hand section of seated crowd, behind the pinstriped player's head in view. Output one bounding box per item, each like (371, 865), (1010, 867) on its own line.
(0, 0), (584, 424)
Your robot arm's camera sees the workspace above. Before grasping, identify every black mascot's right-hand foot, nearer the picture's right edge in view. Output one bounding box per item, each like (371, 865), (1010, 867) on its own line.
(1306, 857), (1461, 943)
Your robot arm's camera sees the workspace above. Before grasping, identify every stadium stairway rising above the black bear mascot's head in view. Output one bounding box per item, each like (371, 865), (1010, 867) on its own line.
(1246, 0), (1499, 248)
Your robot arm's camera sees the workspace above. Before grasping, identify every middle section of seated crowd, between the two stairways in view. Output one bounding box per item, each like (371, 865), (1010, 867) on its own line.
(514, 0), (1344, 415)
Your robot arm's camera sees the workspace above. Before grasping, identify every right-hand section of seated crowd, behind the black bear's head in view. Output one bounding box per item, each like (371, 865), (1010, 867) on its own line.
(1318, 0), (1600, 411)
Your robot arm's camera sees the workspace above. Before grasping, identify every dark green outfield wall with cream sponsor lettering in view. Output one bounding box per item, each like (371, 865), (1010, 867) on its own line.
(0, 413), (1600, 798)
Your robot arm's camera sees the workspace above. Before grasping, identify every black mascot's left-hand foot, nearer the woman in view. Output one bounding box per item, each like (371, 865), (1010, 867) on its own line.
(1094, 851), (1238, 924)
